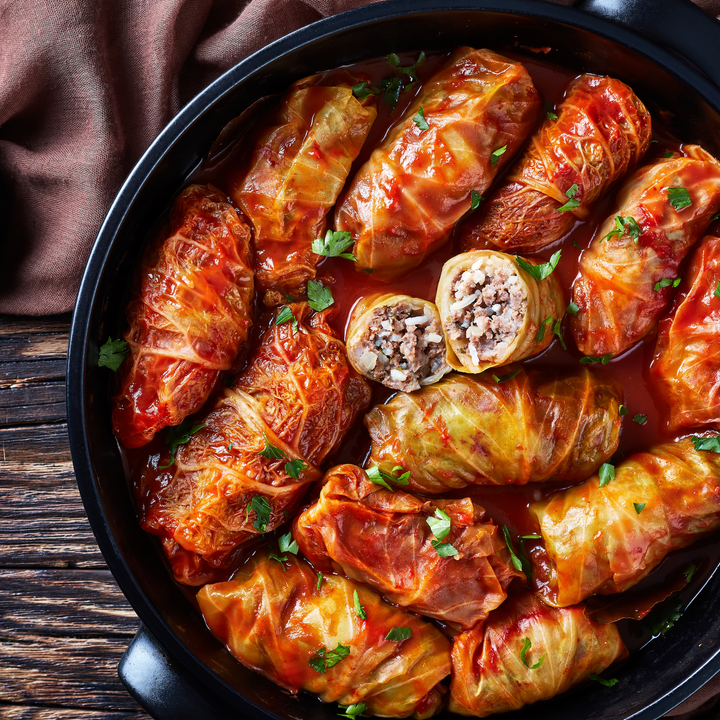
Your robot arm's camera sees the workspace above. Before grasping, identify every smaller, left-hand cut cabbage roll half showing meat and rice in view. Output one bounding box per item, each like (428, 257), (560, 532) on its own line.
(346, 293), (450, 392)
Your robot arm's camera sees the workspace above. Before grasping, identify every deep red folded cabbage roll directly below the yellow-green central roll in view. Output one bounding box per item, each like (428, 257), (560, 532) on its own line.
(293, 465), (525, 629)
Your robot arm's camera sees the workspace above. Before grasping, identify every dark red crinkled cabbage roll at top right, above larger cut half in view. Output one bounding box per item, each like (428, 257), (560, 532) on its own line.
(461, 74), (652, 251)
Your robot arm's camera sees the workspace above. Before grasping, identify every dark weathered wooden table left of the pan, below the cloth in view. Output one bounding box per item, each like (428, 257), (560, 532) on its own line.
(0, 316), (148, 720)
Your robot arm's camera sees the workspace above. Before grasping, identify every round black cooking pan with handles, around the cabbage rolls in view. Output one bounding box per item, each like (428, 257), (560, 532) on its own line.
(67, 0), (720, 720)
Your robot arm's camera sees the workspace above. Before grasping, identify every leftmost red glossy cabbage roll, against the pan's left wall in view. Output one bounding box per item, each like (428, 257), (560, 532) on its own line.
(112, 185), (253, 448)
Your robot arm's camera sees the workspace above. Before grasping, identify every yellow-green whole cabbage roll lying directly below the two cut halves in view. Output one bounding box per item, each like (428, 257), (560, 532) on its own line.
(365, 369), (622, 493)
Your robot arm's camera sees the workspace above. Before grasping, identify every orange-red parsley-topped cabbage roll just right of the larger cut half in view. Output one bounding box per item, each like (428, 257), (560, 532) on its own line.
(570, 145), (720, 357)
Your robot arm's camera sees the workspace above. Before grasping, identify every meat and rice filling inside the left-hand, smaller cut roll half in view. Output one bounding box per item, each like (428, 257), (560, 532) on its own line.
(358, 303), (445, 392)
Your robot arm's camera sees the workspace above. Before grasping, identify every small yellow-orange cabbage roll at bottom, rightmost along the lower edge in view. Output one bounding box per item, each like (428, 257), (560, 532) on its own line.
(449, 594), (628, 717)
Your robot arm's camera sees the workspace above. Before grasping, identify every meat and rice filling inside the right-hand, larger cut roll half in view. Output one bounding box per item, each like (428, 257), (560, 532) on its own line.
(446, 257), (527, 365)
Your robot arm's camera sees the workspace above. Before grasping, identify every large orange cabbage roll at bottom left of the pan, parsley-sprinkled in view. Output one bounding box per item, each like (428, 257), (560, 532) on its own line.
(197, 555), (450, 720)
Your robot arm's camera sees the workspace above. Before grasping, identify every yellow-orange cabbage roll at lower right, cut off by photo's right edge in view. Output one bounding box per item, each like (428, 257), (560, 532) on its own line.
(530, 439), (720, 607)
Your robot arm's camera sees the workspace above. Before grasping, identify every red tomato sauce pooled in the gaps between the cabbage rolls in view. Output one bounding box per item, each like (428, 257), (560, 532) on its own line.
(125, 53), (720, 650)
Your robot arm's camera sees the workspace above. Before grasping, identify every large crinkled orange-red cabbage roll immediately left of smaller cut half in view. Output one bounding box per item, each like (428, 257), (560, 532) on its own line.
(139, 303), (370, 585)
